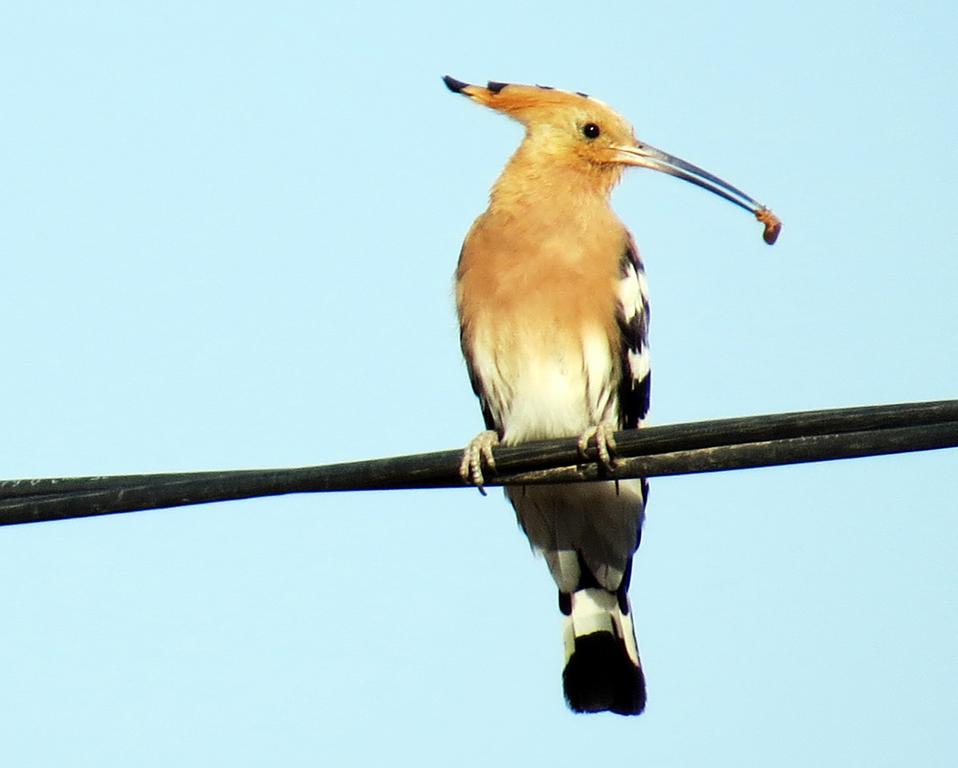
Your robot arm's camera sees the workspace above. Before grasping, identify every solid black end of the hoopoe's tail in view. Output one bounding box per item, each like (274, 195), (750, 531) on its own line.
(562, 632), (645, 715)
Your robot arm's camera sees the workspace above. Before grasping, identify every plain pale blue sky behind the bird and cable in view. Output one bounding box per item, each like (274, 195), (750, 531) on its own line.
(0, 0), (958, 767)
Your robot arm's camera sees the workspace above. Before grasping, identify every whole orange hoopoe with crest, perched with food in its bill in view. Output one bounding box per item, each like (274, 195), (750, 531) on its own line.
(443, 76), (780, 715)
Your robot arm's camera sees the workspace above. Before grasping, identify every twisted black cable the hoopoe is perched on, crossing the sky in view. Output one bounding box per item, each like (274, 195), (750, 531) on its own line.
(0, 400), (958, 525)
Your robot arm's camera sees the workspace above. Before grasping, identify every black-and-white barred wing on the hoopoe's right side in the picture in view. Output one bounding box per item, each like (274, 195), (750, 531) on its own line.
(617, 236), (652, 429)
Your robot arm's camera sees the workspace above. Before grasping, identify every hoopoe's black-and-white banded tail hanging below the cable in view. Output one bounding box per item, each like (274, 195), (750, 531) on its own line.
(562, 587), (645, 715)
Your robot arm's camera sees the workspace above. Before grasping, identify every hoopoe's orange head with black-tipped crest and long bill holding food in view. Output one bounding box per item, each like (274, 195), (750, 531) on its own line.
(443, 75), (781, 245)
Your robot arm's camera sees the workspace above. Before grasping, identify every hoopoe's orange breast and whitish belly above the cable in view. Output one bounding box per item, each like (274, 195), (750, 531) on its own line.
(457, 213), (622, 443)
